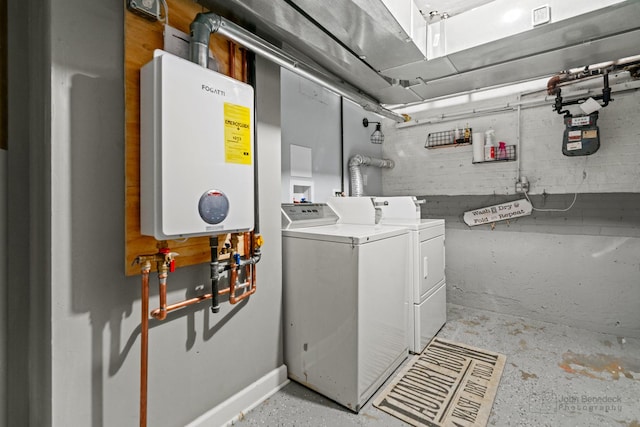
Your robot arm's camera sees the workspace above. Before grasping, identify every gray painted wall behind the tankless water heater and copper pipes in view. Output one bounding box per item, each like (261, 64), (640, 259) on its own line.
(8, 0), (282, 426)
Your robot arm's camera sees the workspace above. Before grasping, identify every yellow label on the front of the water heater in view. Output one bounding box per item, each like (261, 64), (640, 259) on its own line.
(224, 102), (251, 165)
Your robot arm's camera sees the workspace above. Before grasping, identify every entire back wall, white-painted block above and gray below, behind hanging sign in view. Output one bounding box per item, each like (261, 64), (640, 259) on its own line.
(383, 83), (640, 337)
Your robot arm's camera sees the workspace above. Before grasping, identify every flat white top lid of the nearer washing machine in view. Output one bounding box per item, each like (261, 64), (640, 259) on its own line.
(282, 224), (408, 245)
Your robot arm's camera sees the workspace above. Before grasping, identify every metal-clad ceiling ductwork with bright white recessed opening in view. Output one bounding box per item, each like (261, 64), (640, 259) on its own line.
(197, 0), (640, 106)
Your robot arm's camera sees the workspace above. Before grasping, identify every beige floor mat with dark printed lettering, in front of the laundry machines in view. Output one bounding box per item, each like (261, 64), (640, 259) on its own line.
(373, 338), (506, 427)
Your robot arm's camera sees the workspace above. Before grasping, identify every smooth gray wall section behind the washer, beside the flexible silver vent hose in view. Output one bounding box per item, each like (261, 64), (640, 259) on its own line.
(281, 70), (385, 203)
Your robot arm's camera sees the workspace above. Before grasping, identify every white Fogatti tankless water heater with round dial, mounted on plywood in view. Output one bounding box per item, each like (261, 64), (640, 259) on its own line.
(140, 50), (254, 240)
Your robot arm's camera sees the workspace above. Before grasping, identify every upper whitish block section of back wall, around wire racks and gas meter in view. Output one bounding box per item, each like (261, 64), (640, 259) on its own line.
(383, 92), (640, 195)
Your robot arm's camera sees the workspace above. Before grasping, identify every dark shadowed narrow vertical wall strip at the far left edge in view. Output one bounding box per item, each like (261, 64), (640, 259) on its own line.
(3, 1), (51, 426)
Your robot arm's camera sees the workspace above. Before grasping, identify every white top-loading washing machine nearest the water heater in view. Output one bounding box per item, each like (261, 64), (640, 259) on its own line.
(282, 203), (409, 412)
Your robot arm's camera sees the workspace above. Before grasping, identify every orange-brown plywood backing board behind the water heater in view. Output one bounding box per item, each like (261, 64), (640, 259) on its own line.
(123, 0), (246, 275)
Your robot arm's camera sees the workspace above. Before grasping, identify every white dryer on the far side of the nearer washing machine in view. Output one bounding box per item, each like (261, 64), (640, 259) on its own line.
(329, 196), (447, 353)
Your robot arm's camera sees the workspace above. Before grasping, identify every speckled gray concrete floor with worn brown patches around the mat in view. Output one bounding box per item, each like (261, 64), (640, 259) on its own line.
(237, 305), (640, 427)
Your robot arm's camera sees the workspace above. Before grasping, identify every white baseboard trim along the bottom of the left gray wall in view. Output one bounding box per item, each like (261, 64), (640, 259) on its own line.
(187, 365), (289, 427)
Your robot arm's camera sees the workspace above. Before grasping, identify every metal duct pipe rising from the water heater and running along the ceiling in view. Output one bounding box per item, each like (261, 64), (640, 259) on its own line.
(190, 12), (405, 123)
